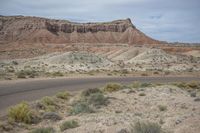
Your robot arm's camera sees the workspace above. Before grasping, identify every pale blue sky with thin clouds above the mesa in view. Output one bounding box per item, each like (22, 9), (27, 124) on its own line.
(0, 0), (200, 43)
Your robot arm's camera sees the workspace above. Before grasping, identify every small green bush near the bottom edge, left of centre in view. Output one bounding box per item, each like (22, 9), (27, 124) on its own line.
(60, 120), (79, 131)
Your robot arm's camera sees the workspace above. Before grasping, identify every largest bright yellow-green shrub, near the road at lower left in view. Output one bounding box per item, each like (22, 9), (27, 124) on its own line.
(8, 102), (34, 124)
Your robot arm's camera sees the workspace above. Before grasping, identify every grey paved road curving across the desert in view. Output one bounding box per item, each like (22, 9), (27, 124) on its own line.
(0, 77), (200, 111)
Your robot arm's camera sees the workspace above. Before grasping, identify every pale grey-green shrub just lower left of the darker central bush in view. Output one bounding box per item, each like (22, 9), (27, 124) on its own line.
(70, 101), (94, 115)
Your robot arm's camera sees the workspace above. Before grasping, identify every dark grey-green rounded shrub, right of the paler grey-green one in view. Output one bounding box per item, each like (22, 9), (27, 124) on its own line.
(88, 93), (107, 107)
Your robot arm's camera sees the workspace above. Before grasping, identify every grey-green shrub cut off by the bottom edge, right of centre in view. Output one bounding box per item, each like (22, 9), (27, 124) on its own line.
(131, 122), (163, 133)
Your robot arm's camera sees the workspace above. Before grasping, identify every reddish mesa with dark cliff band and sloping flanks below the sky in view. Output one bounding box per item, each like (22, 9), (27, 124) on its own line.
(0, 16), (160, 44)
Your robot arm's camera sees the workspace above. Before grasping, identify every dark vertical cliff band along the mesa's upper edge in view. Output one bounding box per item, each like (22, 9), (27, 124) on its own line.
(45, 19), (135, 33)
